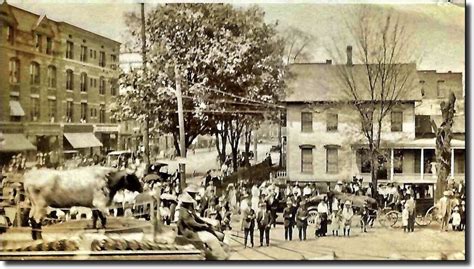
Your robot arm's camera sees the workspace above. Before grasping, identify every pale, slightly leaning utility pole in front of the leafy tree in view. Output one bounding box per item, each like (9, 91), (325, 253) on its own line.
(174, 62), (186, 191)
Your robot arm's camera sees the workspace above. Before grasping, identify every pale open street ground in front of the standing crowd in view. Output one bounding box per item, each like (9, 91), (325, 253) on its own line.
(225, 213), (465, 260)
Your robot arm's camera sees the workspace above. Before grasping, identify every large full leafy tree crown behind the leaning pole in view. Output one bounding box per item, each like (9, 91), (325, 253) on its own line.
(114, 4), (284, 164)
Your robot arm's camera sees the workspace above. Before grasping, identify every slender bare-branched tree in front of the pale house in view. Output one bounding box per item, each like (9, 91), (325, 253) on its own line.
(333, 6), (416, 191)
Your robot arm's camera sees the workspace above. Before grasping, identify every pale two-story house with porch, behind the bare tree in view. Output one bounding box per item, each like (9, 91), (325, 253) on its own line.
(280, 49), (465, 203)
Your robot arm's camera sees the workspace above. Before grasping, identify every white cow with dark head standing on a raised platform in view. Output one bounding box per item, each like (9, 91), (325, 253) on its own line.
(24, 166), (143, 239)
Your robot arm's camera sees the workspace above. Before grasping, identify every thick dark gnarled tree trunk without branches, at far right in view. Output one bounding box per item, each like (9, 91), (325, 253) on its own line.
(431, 92), (456, 199)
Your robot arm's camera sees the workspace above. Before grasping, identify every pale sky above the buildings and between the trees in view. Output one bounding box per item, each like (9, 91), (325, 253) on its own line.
(7, 0), (465, 72)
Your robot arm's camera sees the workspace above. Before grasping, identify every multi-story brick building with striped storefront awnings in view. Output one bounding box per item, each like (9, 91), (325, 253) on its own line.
(0, 2), (120, 163)
